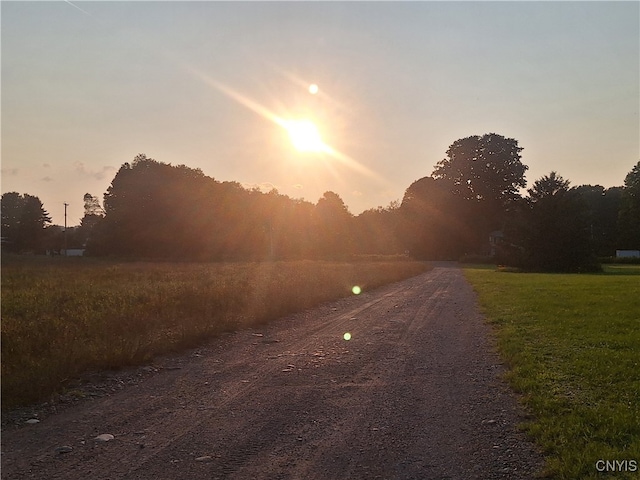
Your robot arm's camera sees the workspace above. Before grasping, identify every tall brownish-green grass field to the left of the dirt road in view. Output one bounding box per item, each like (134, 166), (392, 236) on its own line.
(1, 257), (428, 407)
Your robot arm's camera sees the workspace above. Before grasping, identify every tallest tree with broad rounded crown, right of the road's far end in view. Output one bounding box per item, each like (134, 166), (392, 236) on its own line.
(432, 133), (528, 250)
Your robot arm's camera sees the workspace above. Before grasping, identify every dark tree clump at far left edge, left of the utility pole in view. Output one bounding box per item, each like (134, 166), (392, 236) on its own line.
(1, 192), (51, 252)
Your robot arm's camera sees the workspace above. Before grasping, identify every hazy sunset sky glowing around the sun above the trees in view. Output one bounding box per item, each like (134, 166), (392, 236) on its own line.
(0, 1), (640, 225)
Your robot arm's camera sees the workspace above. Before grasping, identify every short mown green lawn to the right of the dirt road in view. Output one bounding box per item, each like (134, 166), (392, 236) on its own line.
(465, 265), (640, 479)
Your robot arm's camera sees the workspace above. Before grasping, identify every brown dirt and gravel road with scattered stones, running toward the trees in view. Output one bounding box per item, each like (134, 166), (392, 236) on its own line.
(2, 265), (541, 480)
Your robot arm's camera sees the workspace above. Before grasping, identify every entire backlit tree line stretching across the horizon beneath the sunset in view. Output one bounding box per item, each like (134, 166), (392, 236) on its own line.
(2, 133), (640, 271)
